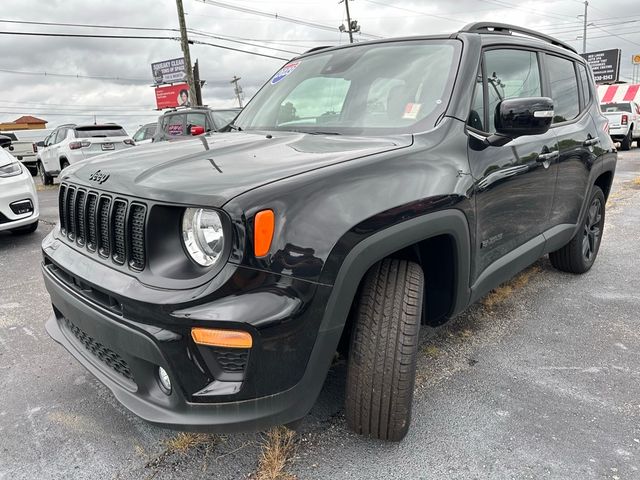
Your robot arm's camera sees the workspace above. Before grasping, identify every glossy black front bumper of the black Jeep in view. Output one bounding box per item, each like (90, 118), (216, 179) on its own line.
(43, 238), (342, 432)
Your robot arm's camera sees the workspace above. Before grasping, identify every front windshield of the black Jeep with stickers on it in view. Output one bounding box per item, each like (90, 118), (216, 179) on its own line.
(235, 40), (460, 135)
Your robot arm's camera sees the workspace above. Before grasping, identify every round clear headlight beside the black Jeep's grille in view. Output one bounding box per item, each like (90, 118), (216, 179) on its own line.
(182, 208), (224, 267)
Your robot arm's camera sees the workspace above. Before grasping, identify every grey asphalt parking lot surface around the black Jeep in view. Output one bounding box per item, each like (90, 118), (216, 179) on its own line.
(0, 148), (640, 480)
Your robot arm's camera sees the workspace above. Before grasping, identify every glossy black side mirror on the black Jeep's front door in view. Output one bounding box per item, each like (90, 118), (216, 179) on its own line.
(487, 97), (553, 146)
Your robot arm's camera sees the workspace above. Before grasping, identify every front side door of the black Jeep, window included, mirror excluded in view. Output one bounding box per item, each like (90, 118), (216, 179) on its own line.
(467, 47), (558, 284)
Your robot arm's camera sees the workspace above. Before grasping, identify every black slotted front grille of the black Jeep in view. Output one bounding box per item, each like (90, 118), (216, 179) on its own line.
(58, 184), (147, 271)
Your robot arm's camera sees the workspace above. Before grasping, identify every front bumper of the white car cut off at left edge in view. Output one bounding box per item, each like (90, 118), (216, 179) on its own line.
(0, 167), (40, 231)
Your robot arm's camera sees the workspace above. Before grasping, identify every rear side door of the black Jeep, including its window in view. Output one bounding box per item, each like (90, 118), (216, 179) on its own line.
(544, 54), (600, 226)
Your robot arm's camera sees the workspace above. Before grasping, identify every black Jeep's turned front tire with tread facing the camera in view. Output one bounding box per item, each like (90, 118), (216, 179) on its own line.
(345, 259), (424, 441)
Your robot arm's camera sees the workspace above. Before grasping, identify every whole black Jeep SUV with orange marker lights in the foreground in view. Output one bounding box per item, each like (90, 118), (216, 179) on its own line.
(42, 24), (616, 440)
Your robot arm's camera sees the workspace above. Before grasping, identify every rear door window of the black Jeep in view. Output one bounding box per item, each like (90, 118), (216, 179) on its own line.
(546, 55), (580, 123)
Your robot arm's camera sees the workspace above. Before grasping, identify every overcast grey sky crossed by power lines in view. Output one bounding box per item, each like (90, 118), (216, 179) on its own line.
(0, 0), (640, 135)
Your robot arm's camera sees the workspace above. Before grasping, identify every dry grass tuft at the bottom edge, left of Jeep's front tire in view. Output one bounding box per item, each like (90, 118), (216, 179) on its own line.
(255, 426), (296, 480)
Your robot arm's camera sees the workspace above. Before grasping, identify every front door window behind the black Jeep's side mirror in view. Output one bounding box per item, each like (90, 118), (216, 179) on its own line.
(484, 49), (542, 133)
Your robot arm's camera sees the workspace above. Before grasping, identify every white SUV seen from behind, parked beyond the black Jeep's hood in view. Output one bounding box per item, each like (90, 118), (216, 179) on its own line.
(38, 123), (135, 185)
